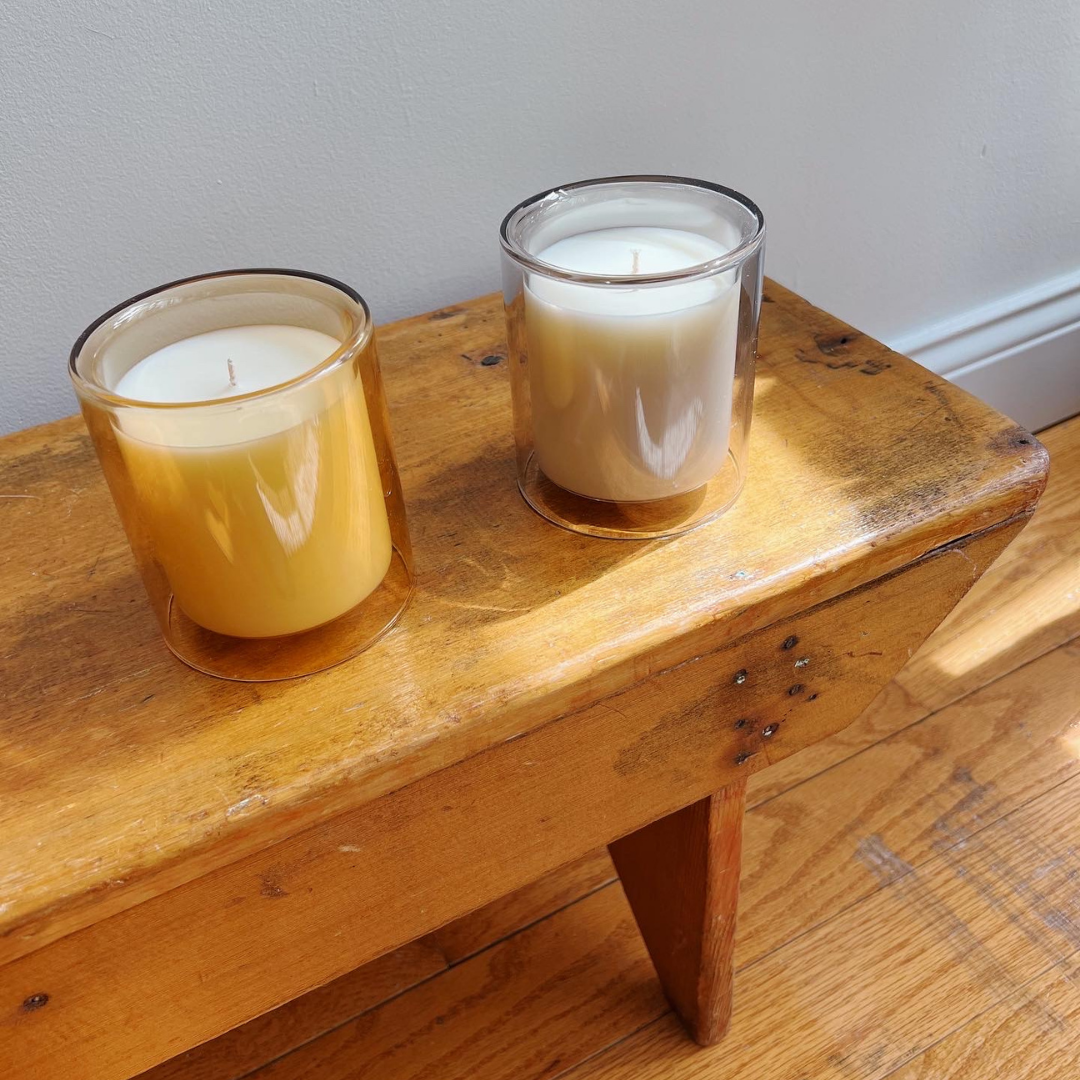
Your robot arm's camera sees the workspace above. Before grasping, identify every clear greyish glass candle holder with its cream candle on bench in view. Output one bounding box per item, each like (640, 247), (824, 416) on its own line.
(501, 176), (765, 539)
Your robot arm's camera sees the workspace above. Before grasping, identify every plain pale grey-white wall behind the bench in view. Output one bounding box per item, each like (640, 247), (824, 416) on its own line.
(0, 0), (1080, 431)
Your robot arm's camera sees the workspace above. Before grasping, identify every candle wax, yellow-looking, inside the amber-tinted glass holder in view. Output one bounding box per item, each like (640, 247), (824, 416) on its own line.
(113, 325), (391, 637)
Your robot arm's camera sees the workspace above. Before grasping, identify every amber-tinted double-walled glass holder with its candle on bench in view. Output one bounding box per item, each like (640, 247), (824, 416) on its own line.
(70, 270), (413, 680)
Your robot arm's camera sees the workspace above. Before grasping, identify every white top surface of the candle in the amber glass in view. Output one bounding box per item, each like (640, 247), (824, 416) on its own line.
(116, 324), (341, 402)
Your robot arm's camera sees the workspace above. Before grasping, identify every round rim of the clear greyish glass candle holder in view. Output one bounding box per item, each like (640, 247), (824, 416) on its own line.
(499, 173), (765, 287)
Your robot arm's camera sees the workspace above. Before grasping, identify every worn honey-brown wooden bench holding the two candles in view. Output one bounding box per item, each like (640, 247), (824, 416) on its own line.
(0, 283), (1047, 1080)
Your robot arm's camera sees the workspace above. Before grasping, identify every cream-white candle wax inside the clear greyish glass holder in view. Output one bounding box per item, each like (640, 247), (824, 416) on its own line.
(525, 226), (740, 502)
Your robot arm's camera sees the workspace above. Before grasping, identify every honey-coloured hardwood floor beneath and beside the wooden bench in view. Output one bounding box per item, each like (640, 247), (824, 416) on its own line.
(144, 418), (1080, 1080)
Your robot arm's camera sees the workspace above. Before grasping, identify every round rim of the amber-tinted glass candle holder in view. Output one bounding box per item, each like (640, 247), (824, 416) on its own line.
(68, 267), (374, 409)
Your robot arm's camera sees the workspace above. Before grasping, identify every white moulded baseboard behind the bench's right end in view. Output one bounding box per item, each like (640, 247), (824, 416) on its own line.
(888, 271), (1080, 430)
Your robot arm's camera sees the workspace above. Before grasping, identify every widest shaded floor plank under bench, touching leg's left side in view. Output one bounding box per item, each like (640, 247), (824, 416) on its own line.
(245, 887), (666, 1080)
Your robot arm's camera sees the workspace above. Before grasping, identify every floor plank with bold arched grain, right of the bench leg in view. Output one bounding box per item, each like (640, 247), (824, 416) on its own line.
(735, 642), (1080, 966)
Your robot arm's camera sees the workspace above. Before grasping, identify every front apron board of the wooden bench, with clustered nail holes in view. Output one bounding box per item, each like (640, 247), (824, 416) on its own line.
(0, 522), (1022, 1080)
